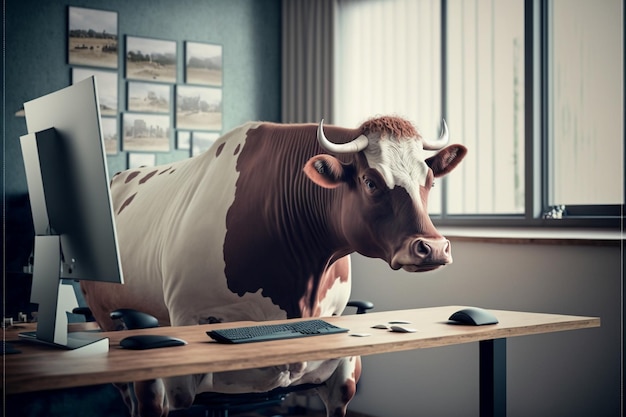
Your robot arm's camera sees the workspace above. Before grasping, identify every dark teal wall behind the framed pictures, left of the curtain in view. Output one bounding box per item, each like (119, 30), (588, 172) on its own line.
(2, 0), (281, 271)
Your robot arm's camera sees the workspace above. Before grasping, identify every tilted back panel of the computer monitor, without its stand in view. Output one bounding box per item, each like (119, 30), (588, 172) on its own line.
(22, 77), (123, 282)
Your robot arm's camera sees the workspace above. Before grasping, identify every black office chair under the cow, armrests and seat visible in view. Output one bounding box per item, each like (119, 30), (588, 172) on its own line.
(111, 300), (374, 417)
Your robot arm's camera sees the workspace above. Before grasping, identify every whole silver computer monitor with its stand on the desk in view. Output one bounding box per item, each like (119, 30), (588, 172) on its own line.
(20, 77), (123, 351)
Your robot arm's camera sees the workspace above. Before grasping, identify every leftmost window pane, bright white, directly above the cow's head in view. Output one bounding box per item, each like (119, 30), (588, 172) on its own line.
(333, 0), (442, 213)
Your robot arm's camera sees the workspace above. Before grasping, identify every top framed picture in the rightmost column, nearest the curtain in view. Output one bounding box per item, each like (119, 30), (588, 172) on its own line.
(185, 42), (223, 87)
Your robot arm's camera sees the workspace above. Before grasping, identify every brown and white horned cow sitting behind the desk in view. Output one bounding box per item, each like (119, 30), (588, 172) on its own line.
(81, 117), (467, 417)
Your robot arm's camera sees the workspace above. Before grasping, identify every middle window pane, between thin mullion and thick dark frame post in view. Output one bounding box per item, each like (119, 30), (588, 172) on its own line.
(445, 0), (525, 215)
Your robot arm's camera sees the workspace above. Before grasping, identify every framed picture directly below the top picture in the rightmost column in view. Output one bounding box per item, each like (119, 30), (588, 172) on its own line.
(176, 85), (222, 130)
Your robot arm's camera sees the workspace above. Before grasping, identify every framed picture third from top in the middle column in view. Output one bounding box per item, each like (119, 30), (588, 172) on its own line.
(122, 113), (172, 152)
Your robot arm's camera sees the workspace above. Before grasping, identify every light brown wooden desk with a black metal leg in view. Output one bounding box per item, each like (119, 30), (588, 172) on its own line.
(5, 306), (600, 417)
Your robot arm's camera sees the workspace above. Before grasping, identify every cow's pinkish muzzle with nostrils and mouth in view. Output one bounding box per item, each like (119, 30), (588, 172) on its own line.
(390, 237), (452, 272)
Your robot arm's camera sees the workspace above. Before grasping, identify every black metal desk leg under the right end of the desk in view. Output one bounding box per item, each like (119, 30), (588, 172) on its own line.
(479, 339), (506, 417)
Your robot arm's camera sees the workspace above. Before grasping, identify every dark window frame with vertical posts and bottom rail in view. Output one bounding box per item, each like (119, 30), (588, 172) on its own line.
(431, 0), (626, 230)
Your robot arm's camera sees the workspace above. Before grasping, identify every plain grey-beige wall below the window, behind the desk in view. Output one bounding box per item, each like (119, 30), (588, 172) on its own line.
(349, 240), (622, 417)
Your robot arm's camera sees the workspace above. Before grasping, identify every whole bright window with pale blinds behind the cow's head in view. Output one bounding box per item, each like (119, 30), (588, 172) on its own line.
(333, 0), (624, 226)
